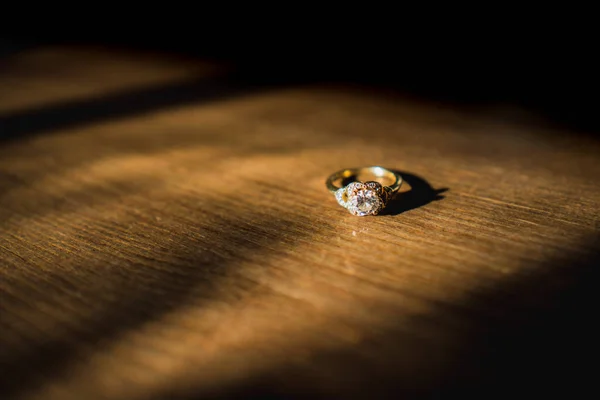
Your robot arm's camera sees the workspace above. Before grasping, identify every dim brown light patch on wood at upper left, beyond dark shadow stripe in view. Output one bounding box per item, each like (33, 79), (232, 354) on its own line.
(0, 47), (225, 115)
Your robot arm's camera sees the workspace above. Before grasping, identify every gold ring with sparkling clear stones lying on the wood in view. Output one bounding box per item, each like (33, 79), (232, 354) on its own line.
(325, 167), (402, 217)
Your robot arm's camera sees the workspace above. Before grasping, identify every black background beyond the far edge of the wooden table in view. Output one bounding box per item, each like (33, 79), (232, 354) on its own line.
(0, 19), (600, 134)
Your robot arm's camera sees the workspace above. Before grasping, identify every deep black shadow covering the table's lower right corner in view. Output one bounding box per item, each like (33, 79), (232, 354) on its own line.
(166, 234), (600, 400)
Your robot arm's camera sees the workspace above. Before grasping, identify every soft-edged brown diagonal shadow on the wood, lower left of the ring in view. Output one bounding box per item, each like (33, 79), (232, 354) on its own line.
(0, 193), (318, 399)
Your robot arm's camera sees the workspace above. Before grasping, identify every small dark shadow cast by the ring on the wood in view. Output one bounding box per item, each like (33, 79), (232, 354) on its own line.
(342, 169), (449, 215)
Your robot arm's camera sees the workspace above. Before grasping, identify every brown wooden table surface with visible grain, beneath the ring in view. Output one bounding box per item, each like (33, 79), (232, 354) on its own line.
(0, 47), (600, 400)
